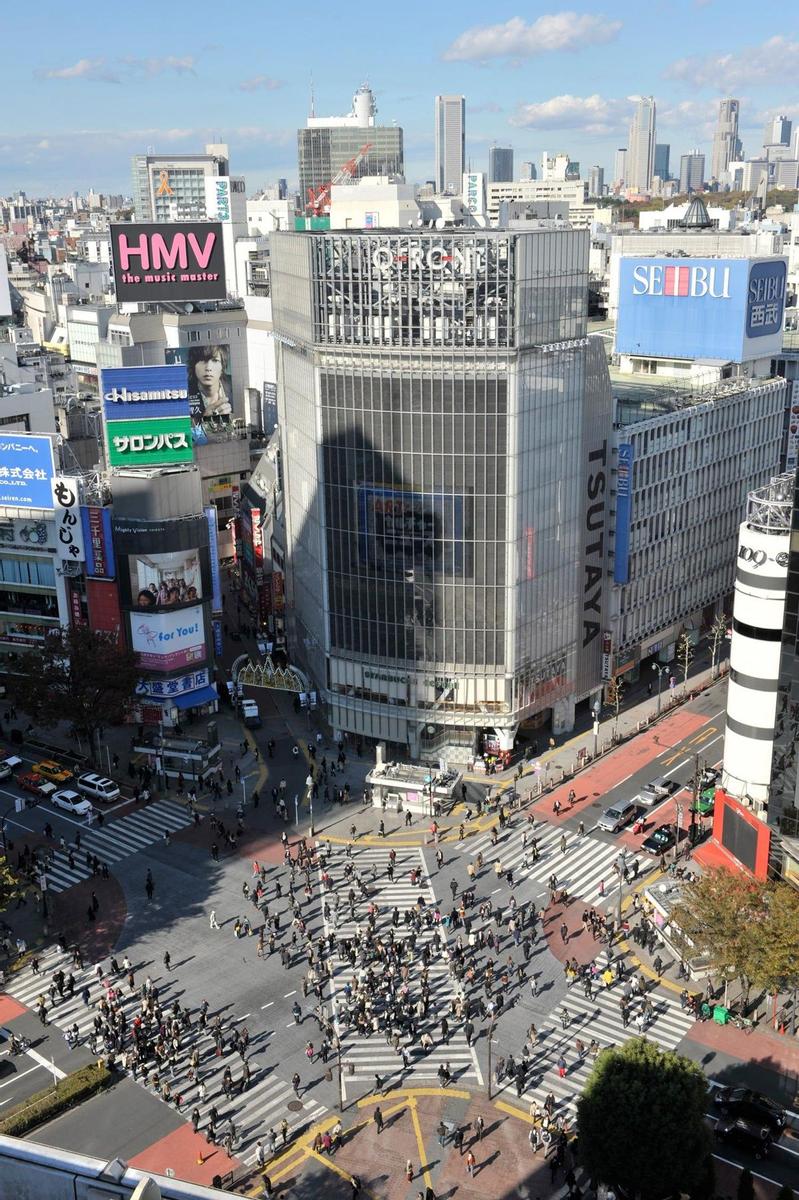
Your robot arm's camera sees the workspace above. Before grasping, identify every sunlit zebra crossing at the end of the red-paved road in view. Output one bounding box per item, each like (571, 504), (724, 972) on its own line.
(458, 822), (628, 905)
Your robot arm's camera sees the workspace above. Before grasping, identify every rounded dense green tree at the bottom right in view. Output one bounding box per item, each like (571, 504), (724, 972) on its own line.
(577, 1038), (710, 1200)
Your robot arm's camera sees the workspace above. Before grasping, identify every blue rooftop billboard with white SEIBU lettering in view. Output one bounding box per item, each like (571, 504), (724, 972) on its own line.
(615, 258), (787, 362)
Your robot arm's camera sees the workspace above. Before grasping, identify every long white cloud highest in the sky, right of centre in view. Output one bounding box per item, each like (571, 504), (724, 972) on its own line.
(441, 12), (621, 62)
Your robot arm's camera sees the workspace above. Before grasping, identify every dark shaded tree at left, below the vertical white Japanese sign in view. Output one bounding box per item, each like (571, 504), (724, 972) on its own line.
(13, 625), (140, 752)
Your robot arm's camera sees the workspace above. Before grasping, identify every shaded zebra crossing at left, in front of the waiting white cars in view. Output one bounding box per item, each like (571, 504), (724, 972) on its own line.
(38, 799), (193, 892)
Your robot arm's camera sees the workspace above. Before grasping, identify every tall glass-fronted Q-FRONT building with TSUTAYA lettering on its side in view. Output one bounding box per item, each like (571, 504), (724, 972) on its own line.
(267, 229), (611, 756)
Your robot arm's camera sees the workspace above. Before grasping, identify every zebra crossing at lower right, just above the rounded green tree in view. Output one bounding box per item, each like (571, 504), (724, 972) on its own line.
(492, 950), (695, 1114)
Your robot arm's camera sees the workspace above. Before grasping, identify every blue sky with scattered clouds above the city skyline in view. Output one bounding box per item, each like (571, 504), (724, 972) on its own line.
(0, 0), (799, 196)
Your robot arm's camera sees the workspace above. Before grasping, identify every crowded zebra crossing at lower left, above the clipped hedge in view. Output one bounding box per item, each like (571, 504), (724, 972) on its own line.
(6, 950), (328, 1164)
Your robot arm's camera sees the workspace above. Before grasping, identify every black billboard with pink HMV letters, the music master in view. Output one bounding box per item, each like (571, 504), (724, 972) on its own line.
(110, 221), (227, 304)
